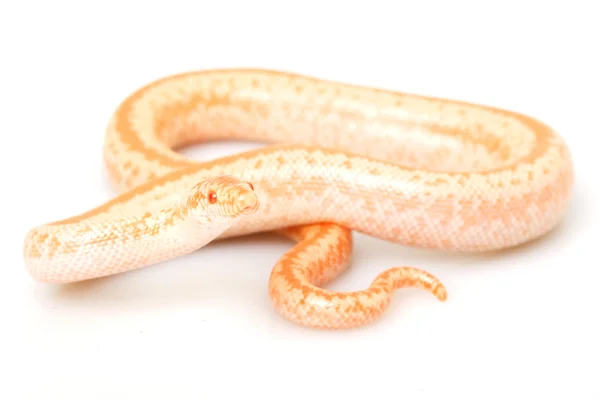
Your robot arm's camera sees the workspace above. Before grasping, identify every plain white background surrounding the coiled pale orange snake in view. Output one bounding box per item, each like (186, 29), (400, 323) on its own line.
(0, 1), (600, 399)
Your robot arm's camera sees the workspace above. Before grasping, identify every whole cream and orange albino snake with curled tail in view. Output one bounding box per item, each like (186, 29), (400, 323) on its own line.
(24, 68), (574, 329)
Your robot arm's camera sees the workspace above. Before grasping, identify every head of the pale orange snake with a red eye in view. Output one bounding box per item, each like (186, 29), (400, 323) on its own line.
(184, 176), (259, 221)
